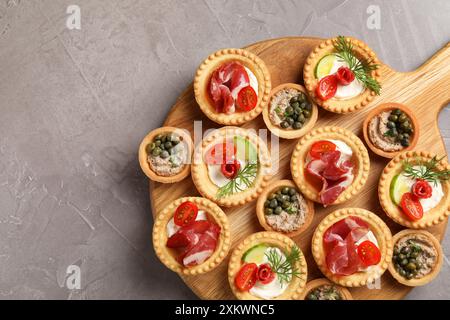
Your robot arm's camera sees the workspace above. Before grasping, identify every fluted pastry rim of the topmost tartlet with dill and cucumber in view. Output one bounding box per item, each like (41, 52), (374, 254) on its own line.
(303, 37), (381, 113)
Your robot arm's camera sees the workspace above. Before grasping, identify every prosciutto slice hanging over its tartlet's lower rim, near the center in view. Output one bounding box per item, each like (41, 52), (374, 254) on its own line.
(306, 150), (353, 207)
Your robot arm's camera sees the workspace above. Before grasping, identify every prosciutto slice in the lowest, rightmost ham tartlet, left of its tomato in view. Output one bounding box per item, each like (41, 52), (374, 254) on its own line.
(323, 217), (369, 276)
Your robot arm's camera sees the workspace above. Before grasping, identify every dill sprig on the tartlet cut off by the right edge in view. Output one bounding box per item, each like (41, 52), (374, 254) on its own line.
(403, 156), (450, 186)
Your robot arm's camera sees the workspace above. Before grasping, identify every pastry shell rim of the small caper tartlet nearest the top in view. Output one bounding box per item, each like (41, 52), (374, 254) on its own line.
(263, 83), (319, 139)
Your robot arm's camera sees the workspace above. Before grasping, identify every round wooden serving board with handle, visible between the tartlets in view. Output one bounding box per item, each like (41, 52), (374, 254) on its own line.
(150, 37), (450, 299)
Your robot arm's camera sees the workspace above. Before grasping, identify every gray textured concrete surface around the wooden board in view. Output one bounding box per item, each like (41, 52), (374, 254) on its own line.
(0, 0), (450, 299)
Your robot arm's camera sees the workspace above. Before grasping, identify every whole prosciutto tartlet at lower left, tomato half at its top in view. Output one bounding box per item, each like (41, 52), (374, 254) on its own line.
(153, 197), (231, 275)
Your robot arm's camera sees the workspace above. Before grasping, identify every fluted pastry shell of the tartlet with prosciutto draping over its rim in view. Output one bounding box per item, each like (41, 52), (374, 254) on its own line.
(291, 127), (370, 205)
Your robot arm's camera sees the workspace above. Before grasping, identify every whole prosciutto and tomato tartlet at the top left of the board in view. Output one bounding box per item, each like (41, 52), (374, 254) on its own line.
(194, 49), (271, 125)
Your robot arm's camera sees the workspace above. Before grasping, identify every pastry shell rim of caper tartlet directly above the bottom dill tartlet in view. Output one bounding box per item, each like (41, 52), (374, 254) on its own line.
(256, 180), (314, 237)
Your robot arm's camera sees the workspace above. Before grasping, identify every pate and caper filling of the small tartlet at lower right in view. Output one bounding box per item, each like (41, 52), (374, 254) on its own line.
(392, 233), (438, 279)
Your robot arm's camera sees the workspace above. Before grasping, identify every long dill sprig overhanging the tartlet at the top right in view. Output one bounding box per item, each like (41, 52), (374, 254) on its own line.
(334, 36), (381, 95)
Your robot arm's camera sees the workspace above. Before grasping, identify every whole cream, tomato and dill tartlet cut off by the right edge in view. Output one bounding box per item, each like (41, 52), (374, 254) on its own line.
(378, 151), (450, 229)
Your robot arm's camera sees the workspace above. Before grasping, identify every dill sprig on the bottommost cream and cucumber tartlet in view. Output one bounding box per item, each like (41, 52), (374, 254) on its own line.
(265, 245), (301, 285)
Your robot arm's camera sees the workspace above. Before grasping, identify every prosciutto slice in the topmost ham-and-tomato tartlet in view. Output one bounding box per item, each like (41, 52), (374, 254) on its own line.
(209, 61), (250, 113)
